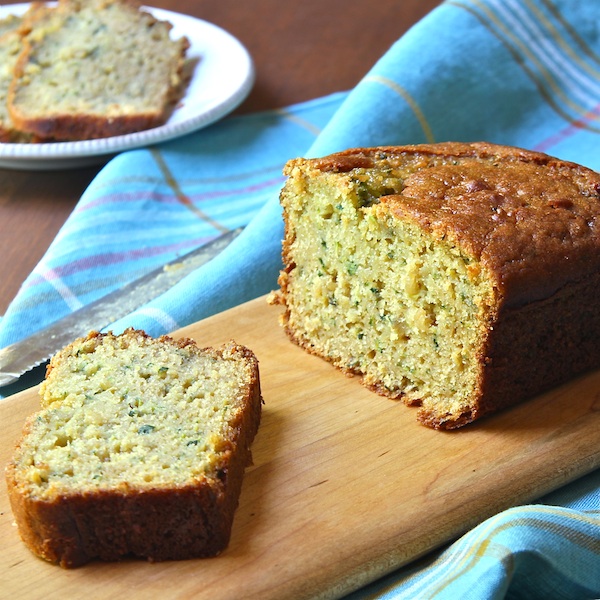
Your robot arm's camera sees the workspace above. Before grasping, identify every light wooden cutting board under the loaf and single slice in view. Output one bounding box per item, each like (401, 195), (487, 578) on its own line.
(0, 298), (600, 600)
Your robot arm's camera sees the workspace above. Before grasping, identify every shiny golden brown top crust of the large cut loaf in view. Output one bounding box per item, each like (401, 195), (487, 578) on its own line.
(300, 142), (600, 306)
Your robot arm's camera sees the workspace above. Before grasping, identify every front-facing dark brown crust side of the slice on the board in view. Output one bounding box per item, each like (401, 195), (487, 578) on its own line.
(7, 468), (246, 568)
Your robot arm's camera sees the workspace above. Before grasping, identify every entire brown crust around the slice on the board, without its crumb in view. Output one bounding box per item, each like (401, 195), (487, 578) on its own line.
(6, 330), (262, 568)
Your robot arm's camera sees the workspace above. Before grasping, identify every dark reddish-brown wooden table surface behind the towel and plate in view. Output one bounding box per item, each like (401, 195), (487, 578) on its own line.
(0, 0), (440, 315)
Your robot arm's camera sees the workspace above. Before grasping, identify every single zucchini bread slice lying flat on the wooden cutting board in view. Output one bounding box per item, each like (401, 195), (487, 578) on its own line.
(6, 329), (262, 567)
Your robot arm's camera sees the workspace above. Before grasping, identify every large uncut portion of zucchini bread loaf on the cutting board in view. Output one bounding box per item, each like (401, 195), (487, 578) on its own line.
(275, 143), (600, 429)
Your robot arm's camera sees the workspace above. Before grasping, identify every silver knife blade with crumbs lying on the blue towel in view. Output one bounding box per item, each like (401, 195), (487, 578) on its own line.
(0, 227), (243, 387)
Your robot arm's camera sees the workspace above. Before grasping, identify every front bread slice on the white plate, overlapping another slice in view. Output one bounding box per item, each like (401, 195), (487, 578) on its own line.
(7, 0), (189, 141)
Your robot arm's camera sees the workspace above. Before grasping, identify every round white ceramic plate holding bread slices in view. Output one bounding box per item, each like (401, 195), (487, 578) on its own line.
(0, 4), (254, 170)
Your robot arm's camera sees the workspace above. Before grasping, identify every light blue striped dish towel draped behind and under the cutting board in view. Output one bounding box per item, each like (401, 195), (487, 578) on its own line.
(0, 0), (600, 600)
